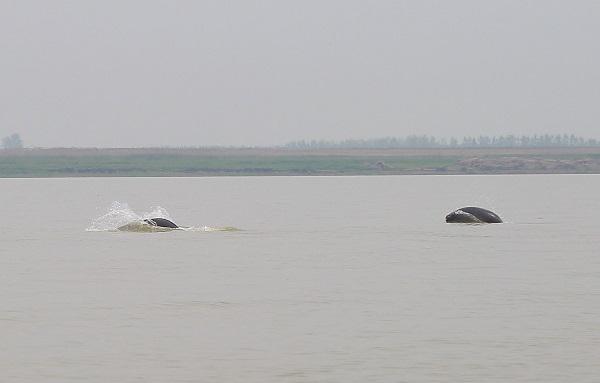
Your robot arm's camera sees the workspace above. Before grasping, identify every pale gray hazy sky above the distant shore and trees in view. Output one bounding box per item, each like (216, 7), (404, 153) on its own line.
(0, 0), (600, 147)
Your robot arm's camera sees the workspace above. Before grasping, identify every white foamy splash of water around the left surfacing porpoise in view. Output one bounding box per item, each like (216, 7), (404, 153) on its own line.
(86, 201), (239, 232)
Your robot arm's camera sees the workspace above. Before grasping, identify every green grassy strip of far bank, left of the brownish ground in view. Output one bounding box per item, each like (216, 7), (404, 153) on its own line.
(0, 154), (456, 177)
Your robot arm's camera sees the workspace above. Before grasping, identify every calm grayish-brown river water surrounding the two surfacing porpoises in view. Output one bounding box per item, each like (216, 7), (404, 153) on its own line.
(0, 175), (600, 383)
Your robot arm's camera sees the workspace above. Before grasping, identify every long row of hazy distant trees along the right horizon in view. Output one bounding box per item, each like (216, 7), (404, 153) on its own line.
(284, 134), (600, 149)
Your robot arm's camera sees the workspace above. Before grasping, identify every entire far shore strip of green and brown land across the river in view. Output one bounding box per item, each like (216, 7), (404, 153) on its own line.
(0, 146), (600, 178)
